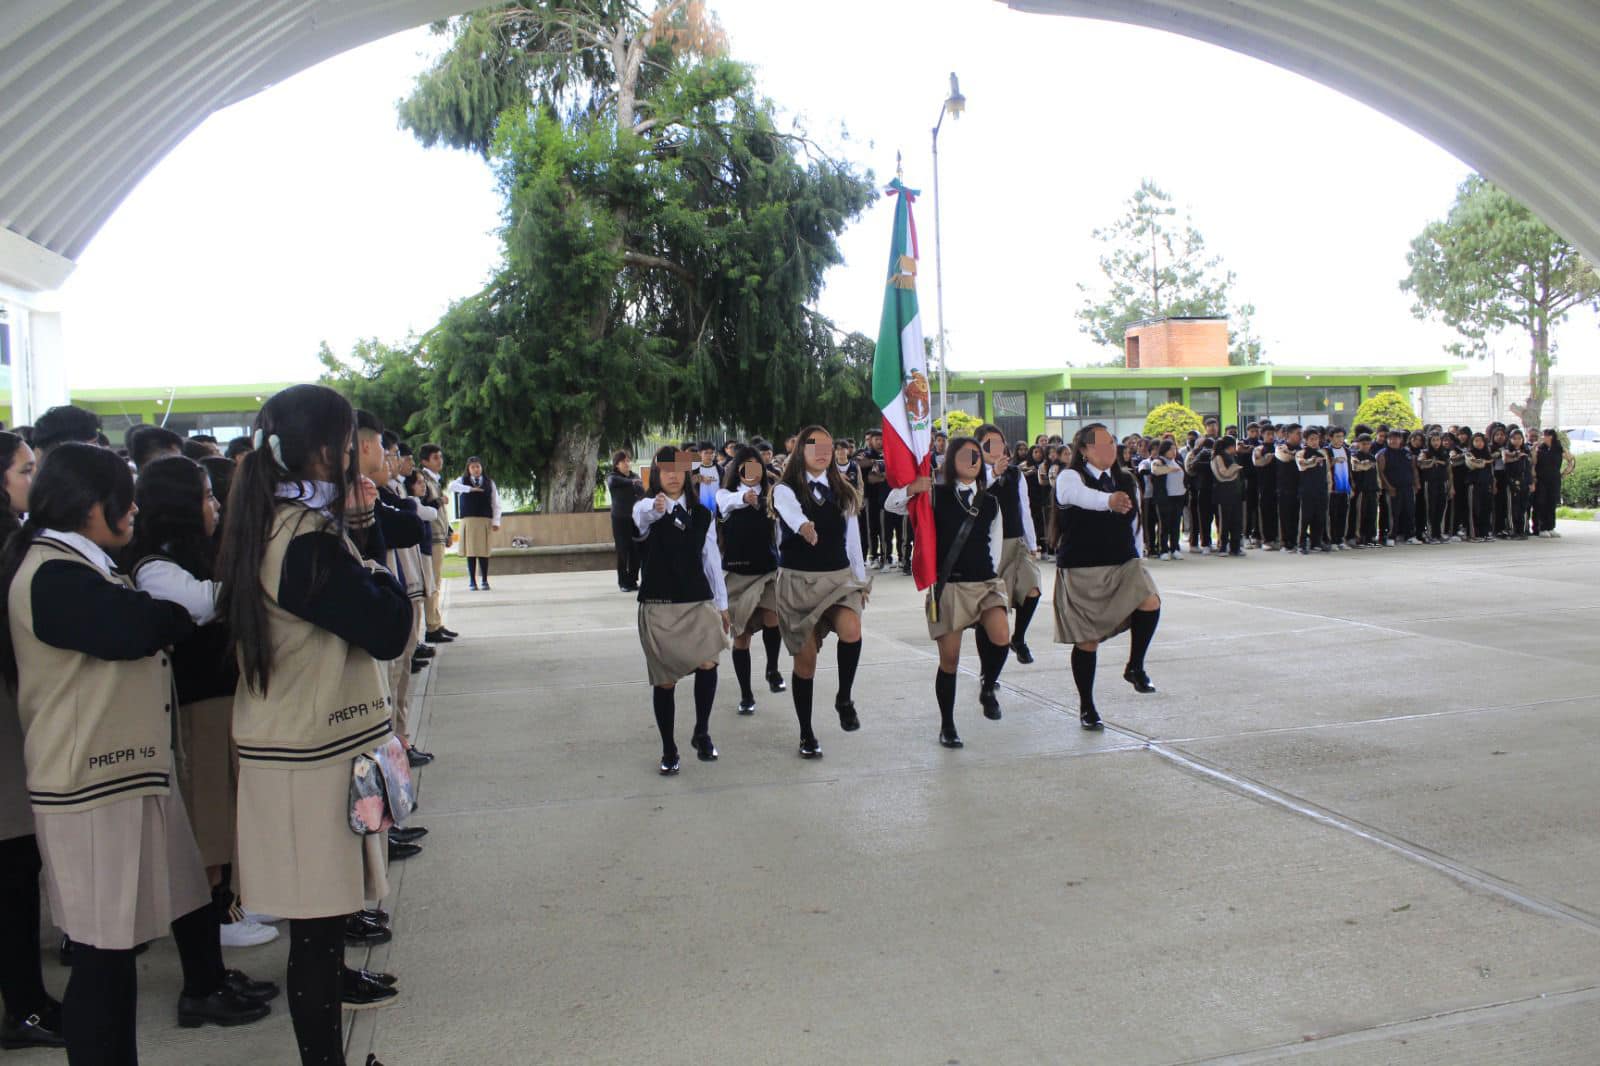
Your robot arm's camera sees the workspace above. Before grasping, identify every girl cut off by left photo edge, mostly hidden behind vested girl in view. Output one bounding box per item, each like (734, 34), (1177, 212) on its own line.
(0, 431), (66, 1050)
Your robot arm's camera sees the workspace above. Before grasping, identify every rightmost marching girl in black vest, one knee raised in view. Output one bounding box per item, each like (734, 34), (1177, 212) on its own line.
(1056, 423), (1162, 730)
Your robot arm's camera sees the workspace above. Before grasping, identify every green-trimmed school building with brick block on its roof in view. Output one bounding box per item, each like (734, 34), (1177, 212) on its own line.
(934, 319), (1459, 442)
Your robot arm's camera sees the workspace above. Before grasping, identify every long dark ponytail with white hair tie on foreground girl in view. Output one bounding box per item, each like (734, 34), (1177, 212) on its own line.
(216, 384), (357, 695)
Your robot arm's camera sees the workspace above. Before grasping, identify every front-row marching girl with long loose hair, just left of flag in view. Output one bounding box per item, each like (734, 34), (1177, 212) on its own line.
(773, 426), (888, 759)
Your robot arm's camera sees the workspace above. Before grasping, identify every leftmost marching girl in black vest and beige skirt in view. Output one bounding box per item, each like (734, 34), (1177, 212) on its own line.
(634, 445), (731, 776)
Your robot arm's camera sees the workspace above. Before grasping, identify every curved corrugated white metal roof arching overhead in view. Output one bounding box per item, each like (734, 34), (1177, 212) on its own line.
(0, 0), (1600, 290)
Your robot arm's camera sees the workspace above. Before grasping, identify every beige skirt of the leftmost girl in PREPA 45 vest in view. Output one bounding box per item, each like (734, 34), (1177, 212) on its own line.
(34, 794), (211, 951)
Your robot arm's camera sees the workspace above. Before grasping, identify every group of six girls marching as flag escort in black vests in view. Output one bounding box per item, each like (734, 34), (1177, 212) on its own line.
(627, 424), (1160, 775)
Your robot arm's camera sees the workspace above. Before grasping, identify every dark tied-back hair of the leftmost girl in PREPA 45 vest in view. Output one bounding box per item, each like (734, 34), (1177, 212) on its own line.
(0, 442), (133, 685)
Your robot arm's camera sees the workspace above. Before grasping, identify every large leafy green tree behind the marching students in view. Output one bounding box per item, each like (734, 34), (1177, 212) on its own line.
(400, 0), (872, 511)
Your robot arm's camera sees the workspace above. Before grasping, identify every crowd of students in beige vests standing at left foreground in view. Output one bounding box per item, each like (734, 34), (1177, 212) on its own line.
(0, 386), (467, 1066)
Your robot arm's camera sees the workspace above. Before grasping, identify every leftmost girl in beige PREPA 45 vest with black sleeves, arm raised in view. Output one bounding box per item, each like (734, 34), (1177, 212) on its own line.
(0, 443), (277, 1066)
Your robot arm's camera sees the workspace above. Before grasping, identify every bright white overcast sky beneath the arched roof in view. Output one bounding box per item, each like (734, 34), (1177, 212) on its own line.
(62, 0), (1600, 386)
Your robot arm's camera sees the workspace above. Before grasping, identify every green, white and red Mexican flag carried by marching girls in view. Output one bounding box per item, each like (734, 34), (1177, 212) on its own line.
(872, 178), (939, 589)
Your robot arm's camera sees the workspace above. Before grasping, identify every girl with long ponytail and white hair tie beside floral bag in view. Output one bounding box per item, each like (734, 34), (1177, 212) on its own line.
(218, 386), (414, 1066)
